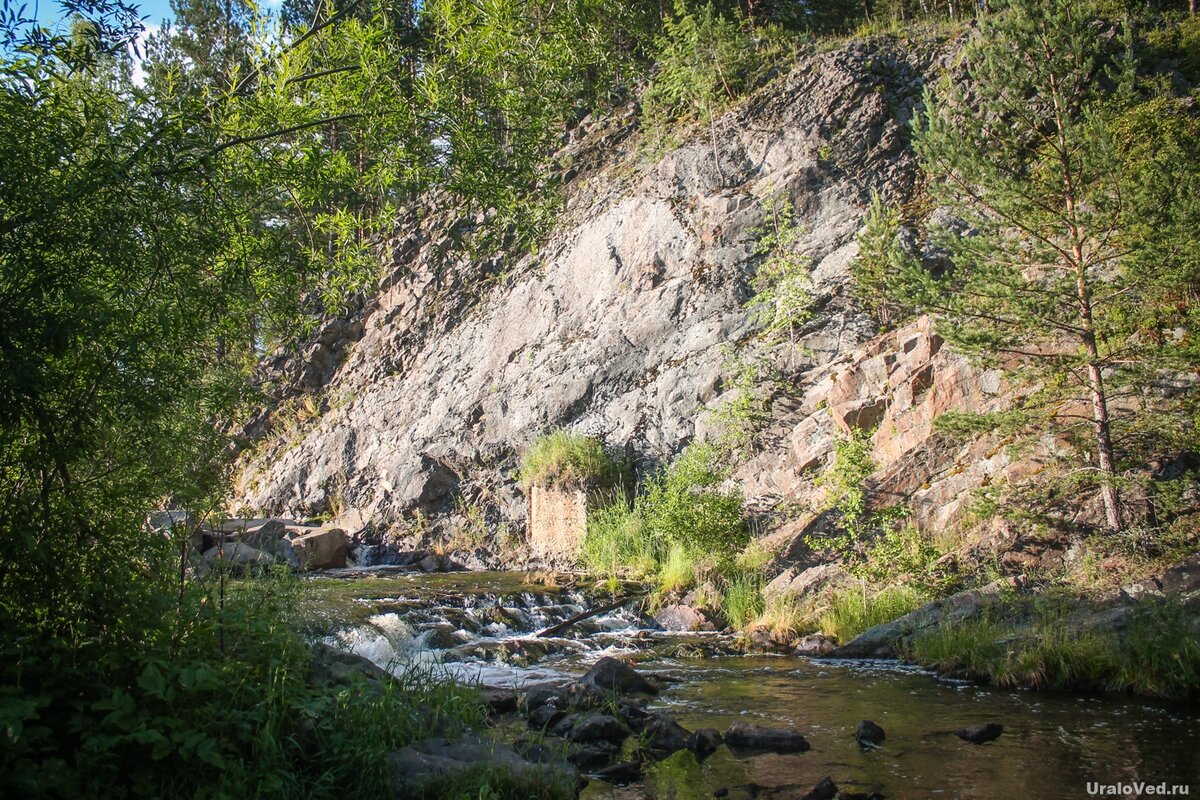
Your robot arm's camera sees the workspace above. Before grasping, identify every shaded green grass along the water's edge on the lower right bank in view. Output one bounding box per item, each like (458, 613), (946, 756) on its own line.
(905, 602), (1200, 699)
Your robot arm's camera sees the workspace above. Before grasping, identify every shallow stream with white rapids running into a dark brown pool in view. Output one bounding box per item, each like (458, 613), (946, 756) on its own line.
(307, 573), (1200, 800)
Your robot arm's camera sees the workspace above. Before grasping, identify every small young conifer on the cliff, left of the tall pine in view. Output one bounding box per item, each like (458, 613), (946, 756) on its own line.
(850, 192), (920, 329)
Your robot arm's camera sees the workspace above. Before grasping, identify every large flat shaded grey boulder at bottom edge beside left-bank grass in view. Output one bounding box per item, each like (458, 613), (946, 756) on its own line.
(389, 736), (578, 793)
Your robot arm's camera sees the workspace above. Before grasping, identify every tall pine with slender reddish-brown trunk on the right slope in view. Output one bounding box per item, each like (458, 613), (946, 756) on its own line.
(908, 0), (1195, 530)
